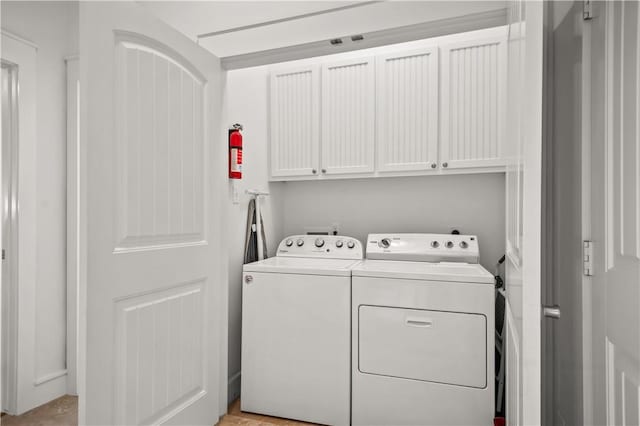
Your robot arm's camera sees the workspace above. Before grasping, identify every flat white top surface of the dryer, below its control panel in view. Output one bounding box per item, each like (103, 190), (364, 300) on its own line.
(352, 260), (495, 284)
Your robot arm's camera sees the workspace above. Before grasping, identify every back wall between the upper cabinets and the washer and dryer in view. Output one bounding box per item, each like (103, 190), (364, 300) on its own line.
(283, 173), (505, 272)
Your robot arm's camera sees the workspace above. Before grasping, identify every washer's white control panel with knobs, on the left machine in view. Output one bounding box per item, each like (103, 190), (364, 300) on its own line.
(276, 235), (364, 260)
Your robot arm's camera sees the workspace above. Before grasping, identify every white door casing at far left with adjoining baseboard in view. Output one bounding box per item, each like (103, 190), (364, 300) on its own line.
(1, 30), (55, 414)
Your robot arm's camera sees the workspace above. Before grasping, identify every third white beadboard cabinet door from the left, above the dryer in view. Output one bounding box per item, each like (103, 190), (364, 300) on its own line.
(376, 47), (438, 172)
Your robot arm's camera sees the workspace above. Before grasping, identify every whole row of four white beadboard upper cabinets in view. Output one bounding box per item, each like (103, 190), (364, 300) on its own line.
(270, 27), (507, 180)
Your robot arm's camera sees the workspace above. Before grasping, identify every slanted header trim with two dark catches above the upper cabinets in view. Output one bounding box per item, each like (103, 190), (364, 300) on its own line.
(221, 9), (507, 70)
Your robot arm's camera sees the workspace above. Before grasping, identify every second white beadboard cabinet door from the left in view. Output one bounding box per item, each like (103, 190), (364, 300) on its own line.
(321, 58), (375, 174)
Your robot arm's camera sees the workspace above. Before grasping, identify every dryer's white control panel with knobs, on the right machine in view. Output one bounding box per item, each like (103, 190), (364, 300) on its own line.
(367, 234), (480, 263)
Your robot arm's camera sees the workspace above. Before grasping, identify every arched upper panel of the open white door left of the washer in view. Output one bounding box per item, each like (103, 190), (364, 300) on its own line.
(115, 33), (206, 251)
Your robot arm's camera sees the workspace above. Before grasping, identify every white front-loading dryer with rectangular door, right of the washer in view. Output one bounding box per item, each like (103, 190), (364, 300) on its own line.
(352, 234), (495, 426)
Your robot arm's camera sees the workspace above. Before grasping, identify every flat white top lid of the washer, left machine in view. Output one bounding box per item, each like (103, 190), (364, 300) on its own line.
(242, 256), (360, 277)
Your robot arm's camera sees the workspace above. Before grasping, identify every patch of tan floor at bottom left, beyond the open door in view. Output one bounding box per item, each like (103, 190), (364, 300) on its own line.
(0, 395), (78, 426)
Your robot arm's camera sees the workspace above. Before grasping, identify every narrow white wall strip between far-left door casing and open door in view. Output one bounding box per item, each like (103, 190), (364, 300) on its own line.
(1, 1), (78, 394)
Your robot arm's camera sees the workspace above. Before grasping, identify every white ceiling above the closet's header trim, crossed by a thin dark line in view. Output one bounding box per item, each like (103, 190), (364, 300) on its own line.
(140, 1), (506, 57)
